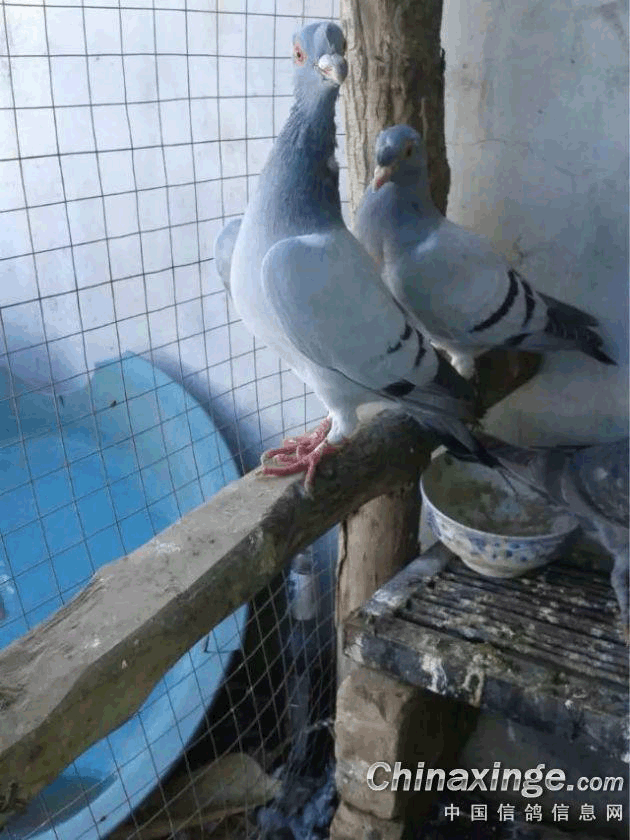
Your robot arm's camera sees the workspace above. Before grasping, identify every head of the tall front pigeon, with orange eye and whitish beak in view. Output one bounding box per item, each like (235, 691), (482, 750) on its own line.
(293, 22), (348, 99)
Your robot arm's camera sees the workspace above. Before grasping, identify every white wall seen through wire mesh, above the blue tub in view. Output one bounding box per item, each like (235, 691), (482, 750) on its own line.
(0, 0), (345, 468)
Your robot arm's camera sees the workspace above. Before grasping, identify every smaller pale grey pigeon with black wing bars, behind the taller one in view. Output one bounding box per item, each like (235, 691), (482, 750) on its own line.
(355, 125), (616, 378)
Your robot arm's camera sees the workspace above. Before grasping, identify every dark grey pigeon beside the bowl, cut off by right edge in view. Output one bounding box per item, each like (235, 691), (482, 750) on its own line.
(479, 433), (630, 640)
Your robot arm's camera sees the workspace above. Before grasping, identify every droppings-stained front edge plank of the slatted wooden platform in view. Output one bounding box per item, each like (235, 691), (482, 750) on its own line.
(344, 619), (628, 761)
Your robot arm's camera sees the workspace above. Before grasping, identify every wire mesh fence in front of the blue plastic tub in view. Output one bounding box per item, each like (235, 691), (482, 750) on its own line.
(0, 0), (345, 840)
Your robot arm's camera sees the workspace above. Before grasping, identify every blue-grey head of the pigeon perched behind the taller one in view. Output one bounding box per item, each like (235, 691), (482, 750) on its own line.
(372, 125), (427, 191)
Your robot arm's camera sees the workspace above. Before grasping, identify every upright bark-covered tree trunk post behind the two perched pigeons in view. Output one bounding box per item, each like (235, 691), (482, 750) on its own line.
(336, 0), (450, 682)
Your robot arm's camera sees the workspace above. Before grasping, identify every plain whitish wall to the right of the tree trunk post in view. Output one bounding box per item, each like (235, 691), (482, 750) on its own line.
(442, 0), (628, 443)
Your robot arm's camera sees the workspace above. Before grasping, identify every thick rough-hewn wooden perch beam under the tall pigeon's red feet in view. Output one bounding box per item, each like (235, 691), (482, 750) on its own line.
(0, 348), (544, 825)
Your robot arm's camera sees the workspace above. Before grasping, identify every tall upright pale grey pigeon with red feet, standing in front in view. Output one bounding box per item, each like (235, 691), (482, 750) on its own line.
(230, 22), (495, 490)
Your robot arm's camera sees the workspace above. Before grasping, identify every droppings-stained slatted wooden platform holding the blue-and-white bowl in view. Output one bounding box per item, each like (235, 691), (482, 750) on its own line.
(344, 561), (629, 761)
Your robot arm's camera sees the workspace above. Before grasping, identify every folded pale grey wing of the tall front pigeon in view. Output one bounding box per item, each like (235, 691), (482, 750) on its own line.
(262, 229), (470, 416)
